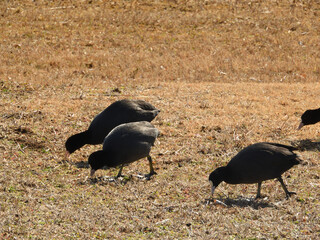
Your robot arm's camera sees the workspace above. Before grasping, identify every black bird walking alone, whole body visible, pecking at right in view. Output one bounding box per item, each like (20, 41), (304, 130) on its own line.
(209, 142), (302, 198)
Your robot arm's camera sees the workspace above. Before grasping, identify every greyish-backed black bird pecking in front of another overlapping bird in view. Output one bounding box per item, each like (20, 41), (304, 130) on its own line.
(88, 121), (159, 179)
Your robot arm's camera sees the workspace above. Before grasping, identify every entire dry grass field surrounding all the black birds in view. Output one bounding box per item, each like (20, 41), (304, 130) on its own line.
(0, 0), (320, 239)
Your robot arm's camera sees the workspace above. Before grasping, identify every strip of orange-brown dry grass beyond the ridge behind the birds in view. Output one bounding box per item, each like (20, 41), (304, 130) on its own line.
(0, 0), (320, 84)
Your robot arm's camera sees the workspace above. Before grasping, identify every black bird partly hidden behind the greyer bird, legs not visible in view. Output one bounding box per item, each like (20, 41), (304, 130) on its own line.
(65, 99), (160, 154)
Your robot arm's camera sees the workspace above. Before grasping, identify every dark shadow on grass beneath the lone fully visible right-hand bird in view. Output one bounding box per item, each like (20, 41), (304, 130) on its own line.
(206, 197), (276, 210)
